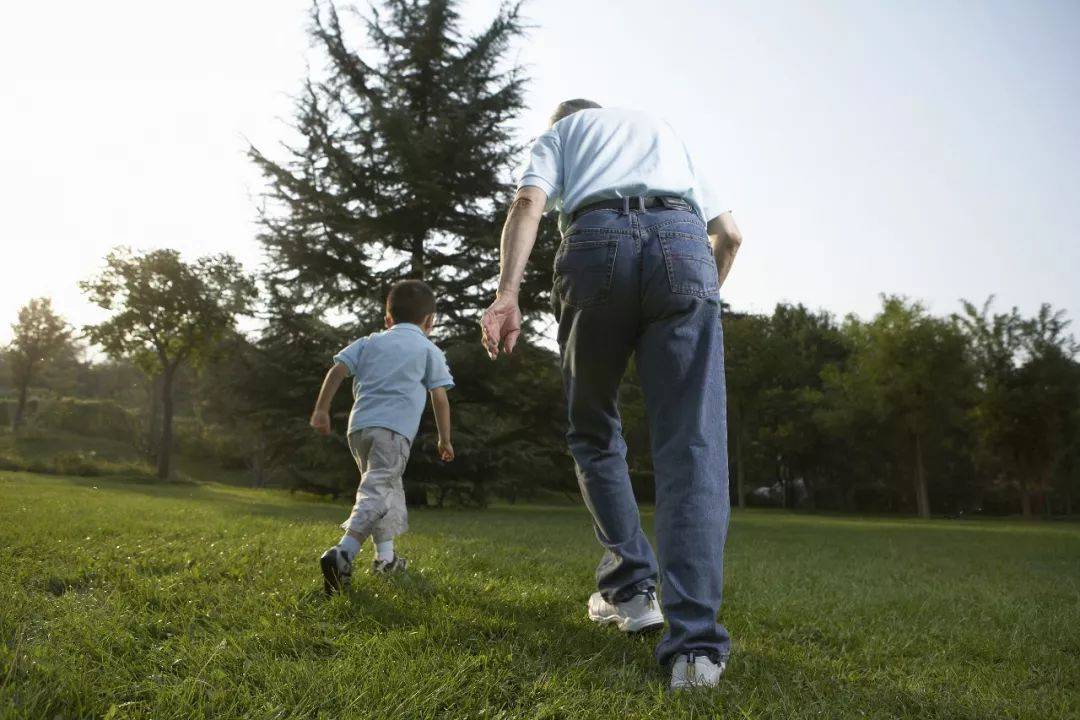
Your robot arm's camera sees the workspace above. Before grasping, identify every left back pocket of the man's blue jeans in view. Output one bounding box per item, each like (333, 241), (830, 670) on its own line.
(552, 232), (619, 308)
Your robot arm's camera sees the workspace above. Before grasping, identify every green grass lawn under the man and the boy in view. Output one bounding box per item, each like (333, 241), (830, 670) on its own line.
(0, 473), (1080, 720)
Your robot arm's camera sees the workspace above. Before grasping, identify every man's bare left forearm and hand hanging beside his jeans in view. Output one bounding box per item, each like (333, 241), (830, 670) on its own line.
(480, 186), (548, 359)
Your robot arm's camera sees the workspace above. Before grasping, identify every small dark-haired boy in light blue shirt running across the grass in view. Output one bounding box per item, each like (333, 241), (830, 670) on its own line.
(311, 280), (454, 595)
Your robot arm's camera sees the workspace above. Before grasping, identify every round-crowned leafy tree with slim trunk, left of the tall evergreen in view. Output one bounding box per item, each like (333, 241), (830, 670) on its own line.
(80, 248), (255, 479)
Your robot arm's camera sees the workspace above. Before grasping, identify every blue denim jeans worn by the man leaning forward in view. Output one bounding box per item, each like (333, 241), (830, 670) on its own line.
(552, 199), (730, 663)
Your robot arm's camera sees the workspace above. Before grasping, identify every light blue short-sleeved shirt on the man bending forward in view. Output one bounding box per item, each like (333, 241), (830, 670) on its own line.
(517, 108), (727, 225)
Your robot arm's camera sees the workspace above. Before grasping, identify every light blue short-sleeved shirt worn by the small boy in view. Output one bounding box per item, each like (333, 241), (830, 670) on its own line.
(334, 323), (454, 441)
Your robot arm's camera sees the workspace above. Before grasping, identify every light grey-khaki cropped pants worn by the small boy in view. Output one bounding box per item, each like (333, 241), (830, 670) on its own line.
(341, 427), (410, 543)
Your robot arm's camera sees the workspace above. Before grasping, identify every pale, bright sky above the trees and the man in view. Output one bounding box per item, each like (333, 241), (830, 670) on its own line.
(0, 0), (1080, 341)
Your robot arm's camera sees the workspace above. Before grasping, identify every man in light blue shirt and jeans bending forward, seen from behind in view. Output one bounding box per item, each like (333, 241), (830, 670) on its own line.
(481, 99), (742, 689)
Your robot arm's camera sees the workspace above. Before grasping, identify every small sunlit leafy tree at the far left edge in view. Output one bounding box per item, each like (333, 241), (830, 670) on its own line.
(8, 298), (73, 427)
